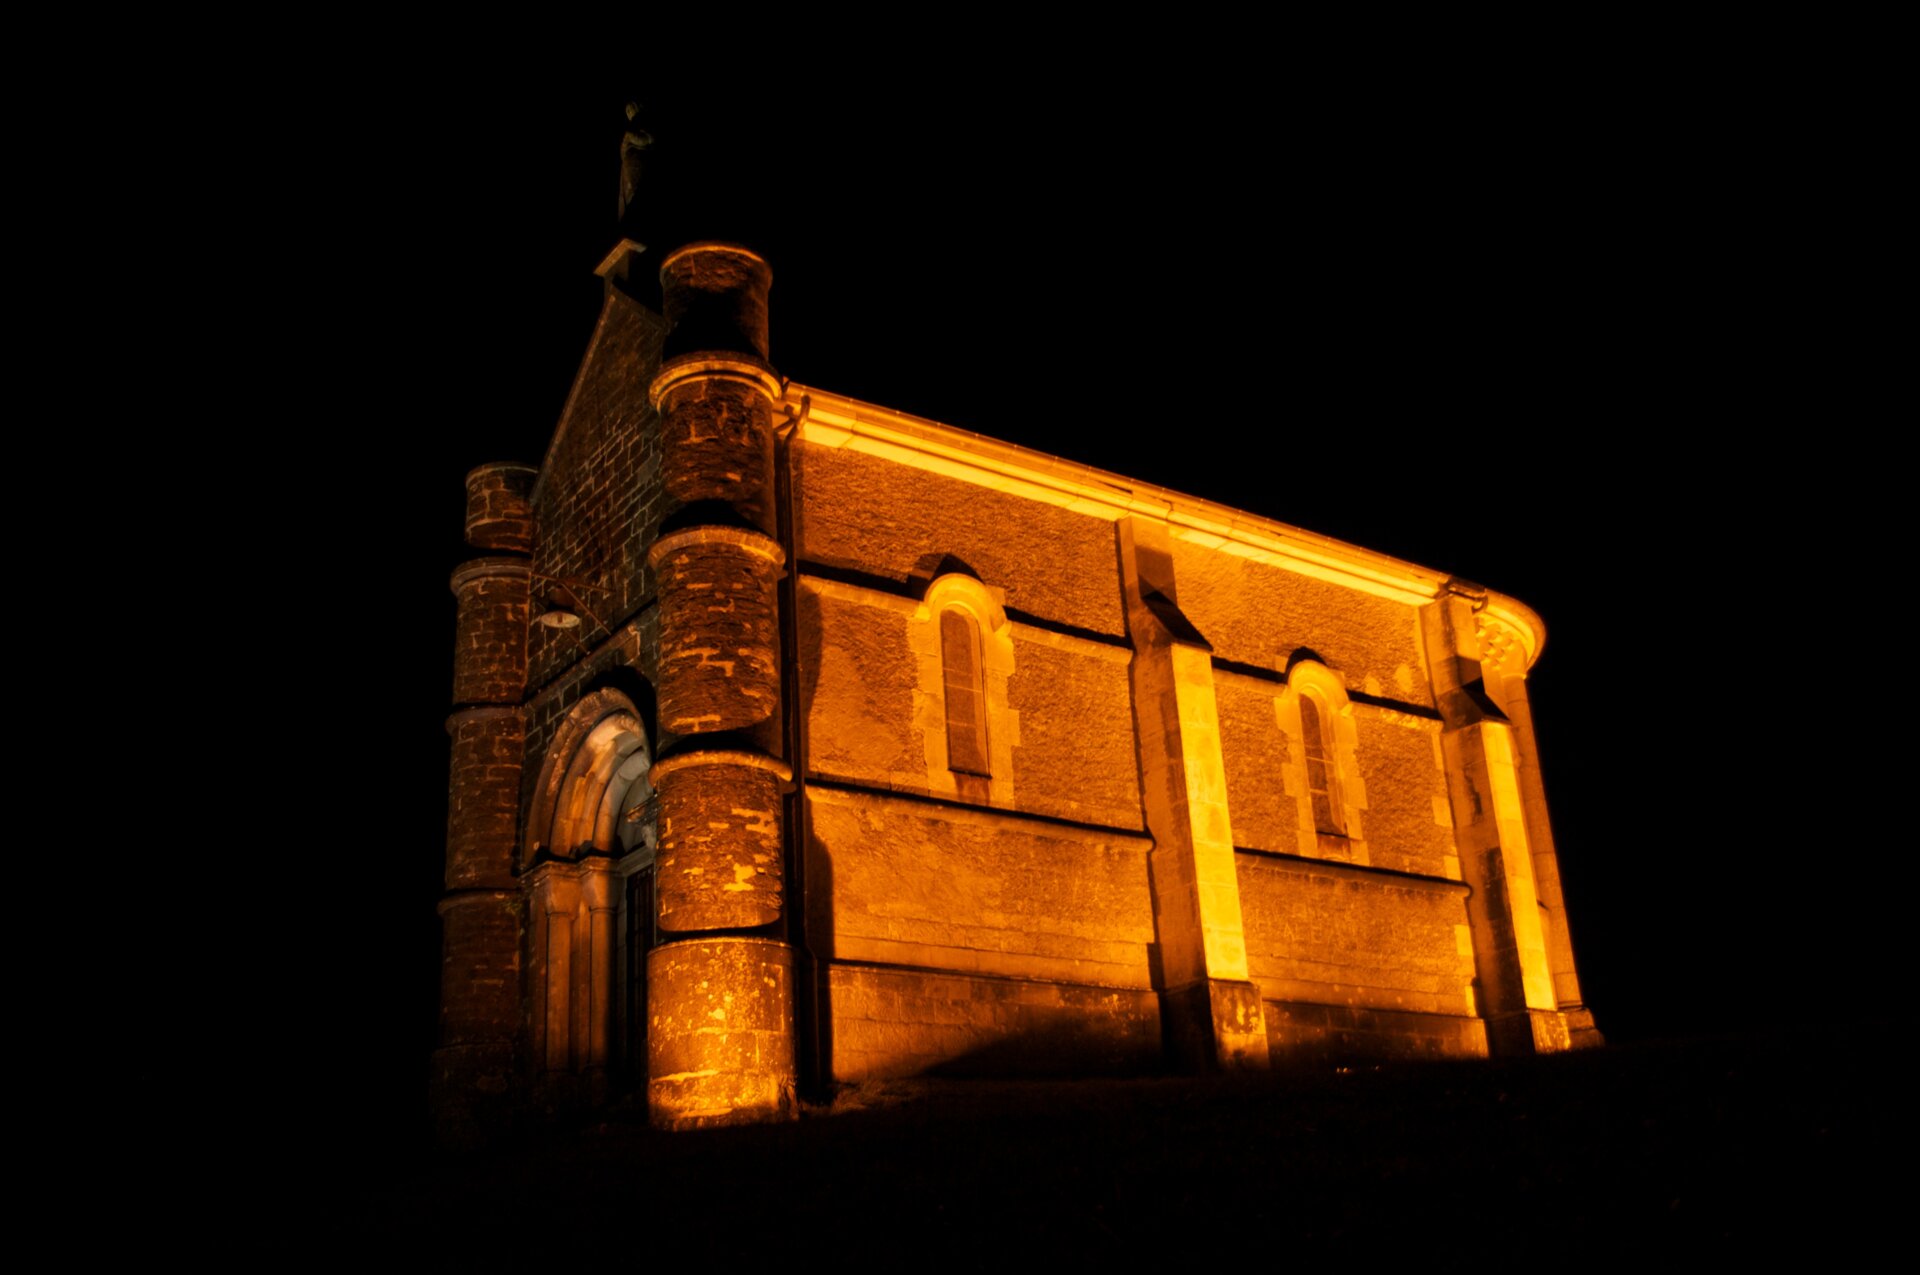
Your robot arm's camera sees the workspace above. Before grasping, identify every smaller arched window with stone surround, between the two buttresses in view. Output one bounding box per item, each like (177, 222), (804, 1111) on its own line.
(1273, 659), (1369, 864)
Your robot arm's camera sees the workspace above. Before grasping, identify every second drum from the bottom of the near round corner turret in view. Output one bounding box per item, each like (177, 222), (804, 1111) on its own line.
(653, 753), (789, 933)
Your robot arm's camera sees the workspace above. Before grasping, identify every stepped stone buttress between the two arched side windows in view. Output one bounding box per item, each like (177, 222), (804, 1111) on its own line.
(1119, 518), (1267, 1071)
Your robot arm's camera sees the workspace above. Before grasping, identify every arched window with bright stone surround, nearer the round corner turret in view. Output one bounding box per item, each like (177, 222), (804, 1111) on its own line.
(908, 572), (1020, 806)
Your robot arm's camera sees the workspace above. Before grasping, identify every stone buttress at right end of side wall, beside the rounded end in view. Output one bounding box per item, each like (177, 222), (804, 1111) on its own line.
(1421, 584), (1571, 1054)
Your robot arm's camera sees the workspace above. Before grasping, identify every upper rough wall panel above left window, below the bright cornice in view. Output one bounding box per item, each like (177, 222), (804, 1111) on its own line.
(795, 444), (1127, 638)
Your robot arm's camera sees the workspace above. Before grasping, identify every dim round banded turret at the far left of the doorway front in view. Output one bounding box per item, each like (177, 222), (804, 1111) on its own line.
(432, 465), (534, 1143)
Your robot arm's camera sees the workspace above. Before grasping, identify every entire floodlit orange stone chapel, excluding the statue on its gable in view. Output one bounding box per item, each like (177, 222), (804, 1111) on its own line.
(434, 244), (1599, 1137)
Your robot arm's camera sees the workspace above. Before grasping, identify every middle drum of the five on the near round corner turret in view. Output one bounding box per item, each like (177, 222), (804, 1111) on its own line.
(653, 528), (781, 735)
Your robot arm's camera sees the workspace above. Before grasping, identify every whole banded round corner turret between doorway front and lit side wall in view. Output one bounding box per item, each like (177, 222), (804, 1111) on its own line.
(647, 244), (795, 1129)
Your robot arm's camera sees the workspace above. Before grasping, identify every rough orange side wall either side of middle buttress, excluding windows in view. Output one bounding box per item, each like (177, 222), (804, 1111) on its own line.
(793, 433), (1520, 1079)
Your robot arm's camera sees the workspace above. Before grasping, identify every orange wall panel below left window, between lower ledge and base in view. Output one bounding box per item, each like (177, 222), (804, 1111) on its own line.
(806, 787), (1154, 987)
